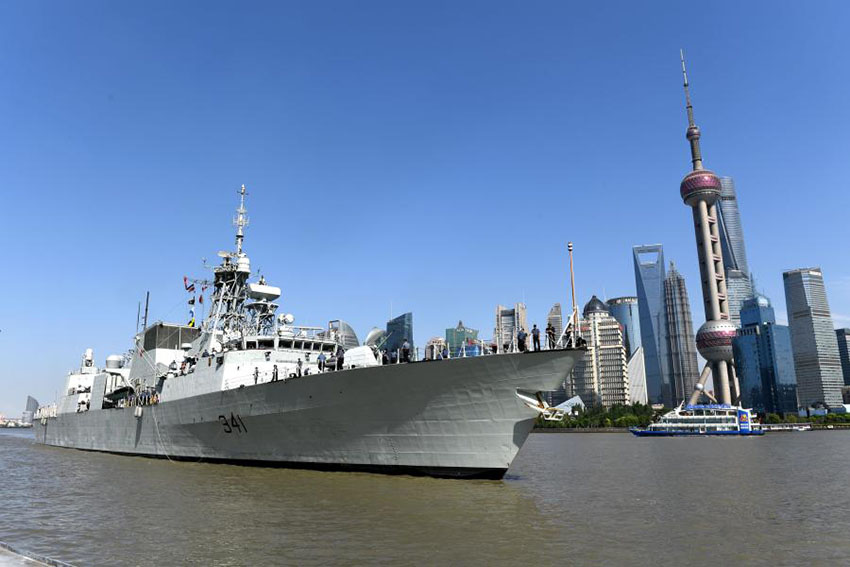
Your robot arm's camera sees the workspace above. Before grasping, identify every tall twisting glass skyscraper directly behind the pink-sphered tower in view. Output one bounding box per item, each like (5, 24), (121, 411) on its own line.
(717, 177), (753, 326)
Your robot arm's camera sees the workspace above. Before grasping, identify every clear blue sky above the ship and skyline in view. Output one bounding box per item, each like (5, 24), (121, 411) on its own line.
(0, 0), (850, 415)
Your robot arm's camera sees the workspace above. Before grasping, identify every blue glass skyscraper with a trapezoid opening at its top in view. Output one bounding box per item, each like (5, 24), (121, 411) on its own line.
(632, 244), (671, 404)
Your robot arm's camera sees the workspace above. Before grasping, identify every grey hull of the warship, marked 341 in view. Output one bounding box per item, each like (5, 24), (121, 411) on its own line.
(35, 350), (583, 478)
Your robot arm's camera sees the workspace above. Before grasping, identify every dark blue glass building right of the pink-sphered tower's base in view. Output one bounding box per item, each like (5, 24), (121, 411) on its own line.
(732, 295), (797, 414)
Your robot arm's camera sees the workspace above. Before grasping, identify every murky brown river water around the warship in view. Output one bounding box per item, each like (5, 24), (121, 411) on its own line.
(0, 430), (850, 565)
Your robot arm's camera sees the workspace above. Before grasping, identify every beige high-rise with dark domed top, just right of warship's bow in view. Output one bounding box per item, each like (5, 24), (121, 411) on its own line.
(571, 295), (630, 407)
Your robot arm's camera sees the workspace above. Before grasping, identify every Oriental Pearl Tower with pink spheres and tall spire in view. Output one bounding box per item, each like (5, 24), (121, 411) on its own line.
(679, 52), (739, 404)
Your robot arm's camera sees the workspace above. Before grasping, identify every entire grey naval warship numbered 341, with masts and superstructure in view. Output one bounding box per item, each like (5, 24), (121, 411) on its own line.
(35, 186), (584, 479)
